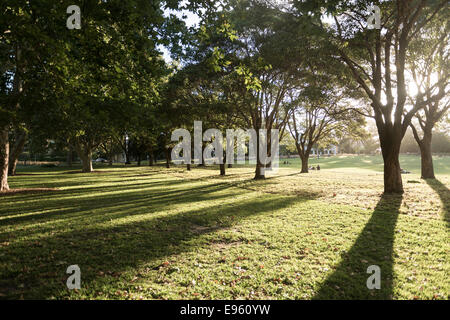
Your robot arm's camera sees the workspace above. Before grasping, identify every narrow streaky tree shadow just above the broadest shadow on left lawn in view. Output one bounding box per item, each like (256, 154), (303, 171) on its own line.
(0, 183), (243, 229)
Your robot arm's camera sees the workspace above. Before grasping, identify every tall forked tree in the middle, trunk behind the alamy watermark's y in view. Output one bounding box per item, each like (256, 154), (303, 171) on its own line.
(221, 0), (324, 179)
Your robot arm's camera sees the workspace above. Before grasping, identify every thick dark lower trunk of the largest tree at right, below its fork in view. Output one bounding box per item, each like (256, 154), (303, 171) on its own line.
(383, 146), (403, 193)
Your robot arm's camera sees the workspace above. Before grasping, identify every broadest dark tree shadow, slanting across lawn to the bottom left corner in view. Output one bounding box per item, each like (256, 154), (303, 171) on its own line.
(0, 190), (314, 299)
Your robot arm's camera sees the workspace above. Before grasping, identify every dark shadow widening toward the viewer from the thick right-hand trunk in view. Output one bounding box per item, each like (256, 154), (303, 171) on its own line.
(313, 195), (402, 299)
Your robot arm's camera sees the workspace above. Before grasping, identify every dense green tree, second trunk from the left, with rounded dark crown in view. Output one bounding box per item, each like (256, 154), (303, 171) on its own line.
(52, 0), (178, 172)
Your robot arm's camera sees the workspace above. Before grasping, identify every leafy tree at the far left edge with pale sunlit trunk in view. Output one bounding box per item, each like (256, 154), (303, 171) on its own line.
(0, 0), (66, 191)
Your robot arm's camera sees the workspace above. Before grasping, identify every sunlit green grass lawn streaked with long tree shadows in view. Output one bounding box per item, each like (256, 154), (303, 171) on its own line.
(0, 156), (450, 299)
